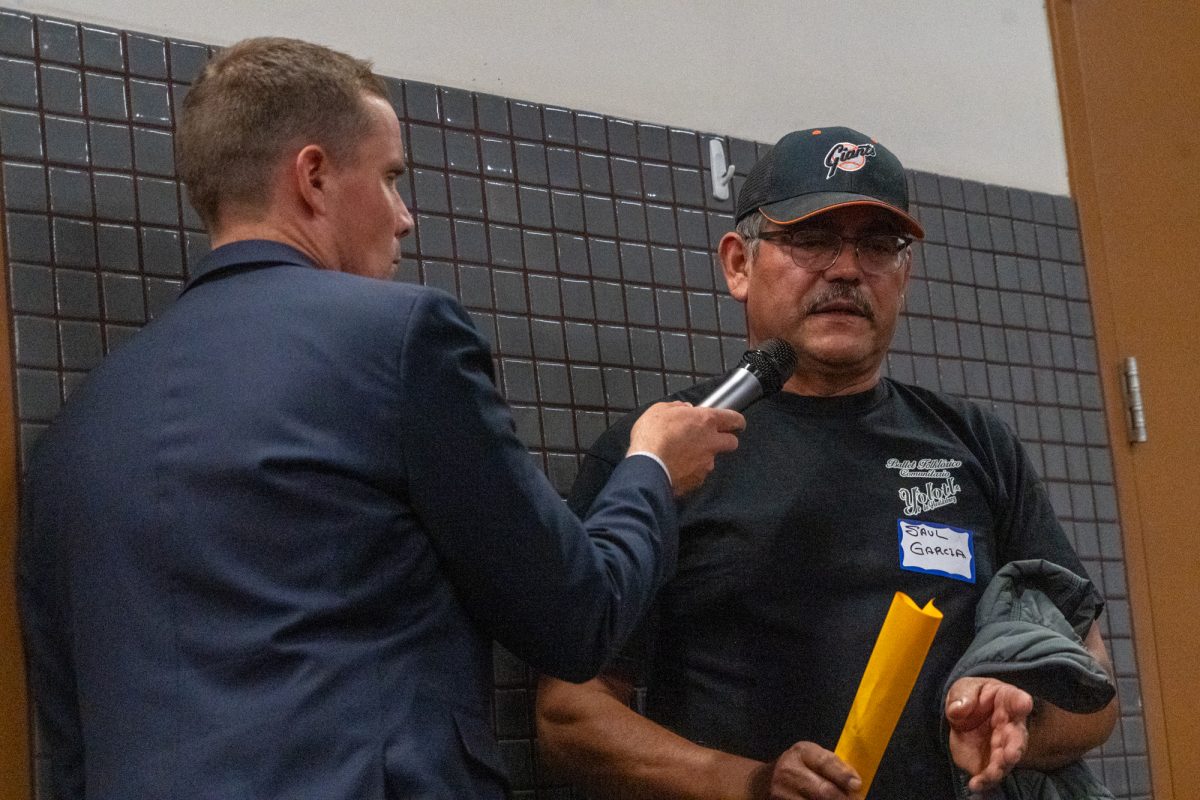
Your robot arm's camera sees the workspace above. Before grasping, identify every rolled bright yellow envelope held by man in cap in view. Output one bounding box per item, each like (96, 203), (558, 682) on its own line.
(834, 591), (942, 798)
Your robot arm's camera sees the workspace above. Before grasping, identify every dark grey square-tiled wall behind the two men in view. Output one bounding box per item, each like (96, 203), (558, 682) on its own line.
(0, 10), (1150, 799)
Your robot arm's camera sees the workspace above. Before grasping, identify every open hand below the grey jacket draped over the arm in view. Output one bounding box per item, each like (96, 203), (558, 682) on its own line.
(946, 678), (1033, 792)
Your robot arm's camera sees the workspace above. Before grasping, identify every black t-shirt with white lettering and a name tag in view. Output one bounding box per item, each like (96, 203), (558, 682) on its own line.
(570, 379), (1086, 800)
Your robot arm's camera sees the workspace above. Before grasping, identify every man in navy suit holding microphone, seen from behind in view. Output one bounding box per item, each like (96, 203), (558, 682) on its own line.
(18, 40), (743, 800)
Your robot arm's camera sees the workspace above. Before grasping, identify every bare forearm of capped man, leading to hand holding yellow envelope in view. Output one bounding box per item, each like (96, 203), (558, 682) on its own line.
(538, 678), (763, 800)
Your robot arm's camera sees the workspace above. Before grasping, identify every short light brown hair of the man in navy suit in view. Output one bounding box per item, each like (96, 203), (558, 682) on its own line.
(175, 37), (388, 230)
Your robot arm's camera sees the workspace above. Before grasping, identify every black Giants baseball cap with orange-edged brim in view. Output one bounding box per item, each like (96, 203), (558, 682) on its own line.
(736, 127), (925, 239)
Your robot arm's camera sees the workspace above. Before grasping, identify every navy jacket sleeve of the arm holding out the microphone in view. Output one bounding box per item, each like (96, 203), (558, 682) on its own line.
(400, 293), (678, 680)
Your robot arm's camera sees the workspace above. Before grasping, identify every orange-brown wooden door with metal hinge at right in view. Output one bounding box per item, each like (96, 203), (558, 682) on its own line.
(1048, 0), (1200, 800)
